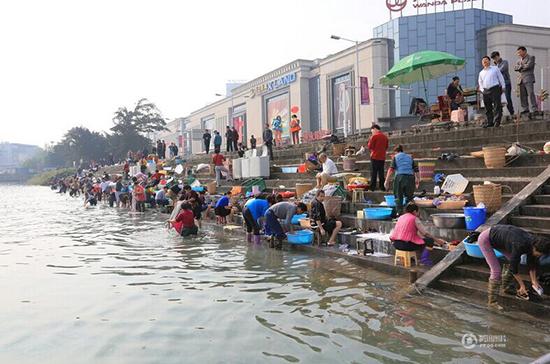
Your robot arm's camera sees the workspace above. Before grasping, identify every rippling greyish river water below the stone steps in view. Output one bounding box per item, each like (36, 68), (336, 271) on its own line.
(0, 185), (550, 363)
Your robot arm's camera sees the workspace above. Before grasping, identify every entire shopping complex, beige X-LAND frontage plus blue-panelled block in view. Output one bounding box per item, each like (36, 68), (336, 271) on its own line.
(181, 7), (550, 153)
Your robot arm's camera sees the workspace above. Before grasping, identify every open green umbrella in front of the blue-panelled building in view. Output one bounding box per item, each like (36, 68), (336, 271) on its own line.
(380, 51), (465, 102)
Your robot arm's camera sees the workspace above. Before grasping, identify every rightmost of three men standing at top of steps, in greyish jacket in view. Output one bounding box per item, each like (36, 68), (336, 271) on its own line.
(514, 46), (538, 116)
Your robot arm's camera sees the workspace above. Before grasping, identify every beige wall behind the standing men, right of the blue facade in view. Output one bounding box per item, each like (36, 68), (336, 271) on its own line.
(487, 24), (550, 111)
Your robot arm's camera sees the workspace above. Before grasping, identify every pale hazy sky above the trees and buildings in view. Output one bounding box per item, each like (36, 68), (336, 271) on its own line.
(0, 0), (550, 146)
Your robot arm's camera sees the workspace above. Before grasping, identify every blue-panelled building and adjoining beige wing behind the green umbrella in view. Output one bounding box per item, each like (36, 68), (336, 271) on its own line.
(373, 8), (550, 116)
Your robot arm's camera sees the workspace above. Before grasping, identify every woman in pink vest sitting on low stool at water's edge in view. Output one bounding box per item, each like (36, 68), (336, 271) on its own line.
(390, 202), (445, 265)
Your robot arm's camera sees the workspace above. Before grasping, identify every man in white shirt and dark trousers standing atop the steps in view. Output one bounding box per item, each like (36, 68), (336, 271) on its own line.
(478, 56), (506, 128)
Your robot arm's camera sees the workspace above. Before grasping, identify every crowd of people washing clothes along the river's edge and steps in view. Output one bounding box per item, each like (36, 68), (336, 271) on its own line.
(52, 112), (550, 309)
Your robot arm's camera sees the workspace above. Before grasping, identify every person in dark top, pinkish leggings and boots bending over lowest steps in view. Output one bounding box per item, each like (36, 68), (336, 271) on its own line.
(477, 225), (550, 310)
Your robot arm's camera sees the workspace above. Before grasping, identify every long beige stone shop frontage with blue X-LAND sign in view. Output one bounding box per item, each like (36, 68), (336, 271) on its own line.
(185, 39), (393, 153)
